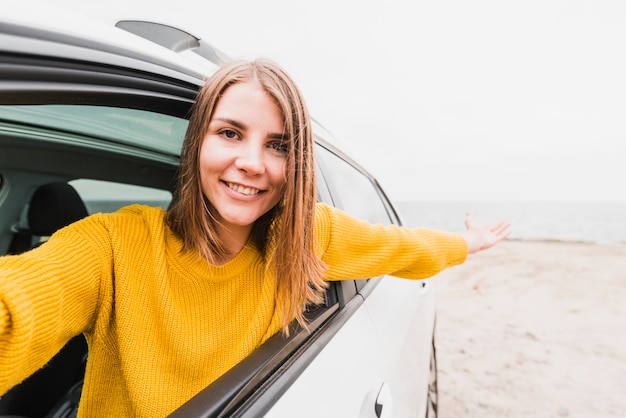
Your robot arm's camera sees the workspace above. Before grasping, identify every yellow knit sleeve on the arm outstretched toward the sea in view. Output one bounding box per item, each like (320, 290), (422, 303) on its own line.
(316, 204), (468, 280)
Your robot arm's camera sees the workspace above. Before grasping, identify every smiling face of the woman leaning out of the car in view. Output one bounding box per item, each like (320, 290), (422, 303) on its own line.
(200, 81), (288, 243)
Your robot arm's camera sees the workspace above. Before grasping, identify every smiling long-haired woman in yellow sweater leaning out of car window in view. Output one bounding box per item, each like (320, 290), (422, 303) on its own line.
(0, 60), (508, 417)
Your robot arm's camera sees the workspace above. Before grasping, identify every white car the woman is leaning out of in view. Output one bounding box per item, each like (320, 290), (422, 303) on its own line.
(0, 7), (437, 418)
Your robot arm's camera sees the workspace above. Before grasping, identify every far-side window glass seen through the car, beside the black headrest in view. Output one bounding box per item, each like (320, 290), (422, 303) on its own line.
(69, 179), (172, 214)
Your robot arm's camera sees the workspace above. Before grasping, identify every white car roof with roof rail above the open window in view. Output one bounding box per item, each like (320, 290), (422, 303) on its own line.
(0, 2), (221, 82)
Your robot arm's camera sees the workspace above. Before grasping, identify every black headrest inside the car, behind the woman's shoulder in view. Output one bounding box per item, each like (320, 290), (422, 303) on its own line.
(28, 182), (88, 236)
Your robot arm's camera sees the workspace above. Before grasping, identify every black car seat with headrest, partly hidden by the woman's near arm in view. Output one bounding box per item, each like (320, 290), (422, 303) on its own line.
(0, 182), (88, 418)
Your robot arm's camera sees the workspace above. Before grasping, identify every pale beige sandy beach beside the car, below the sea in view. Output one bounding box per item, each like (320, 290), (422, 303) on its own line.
(435, 241), (626, 418)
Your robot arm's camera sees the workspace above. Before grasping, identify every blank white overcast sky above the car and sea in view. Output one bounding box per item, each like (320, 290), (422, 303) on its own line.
(37, 0), (626, 201)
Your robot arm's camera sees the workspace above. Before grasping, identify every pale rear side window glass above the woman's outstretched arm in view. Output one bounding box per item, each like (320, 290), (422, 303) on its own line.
(317, 147), (391, 225)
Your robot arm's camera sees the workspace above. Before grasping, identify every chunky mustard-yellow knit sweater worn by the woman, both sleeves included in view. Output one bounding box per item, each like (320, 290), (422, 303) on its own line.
(0, 204), (467, 417)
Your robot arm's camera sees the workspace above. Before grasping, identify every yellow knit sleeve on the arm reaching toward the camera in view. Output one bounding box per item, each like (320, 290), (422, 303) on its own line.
(0, 214), (111, 394)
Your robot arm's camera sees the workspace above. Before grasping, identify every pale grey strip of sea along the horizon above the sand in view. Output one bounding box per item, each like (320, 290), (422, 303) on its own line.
(395, 201), (626, 244)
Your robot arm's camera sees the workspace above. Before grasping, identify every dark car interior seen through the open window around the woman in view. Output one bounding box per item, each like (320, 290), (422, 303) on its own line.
(0, 99), (184, 417)
